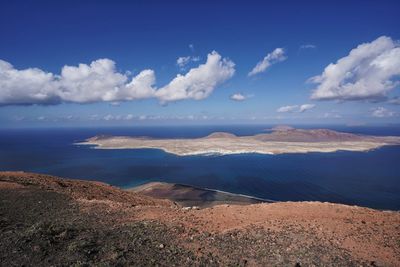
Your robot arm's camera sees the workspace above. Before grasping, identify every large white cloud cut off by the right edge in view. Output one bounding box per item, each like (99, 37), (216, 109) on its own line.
(310, 36), (400, 101)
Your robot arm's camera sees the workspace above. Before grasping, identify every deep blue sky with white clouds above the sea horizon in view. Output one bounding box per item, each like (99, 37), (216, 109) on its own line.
(0, 0), (400, 127)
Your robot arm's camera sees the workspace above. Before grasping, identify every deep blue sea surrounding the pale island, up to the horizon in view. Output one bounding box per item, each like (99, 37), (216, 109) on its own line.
(0, 126), (400, 210)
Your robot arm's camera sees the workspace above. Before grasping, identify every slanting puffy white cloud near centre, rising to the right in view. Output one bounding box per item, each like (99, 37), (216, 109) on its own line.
(155, 51), (235, 102)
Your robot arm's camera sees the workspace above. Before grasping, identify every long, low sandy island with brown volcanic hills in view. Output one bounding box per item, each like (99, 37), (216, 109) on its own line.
(77, 127), (400, 156)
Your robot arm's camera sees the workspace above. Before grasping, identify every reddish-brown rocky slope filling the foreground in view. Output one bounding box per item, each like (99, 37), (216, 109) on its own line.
(0, 172), (400, 266)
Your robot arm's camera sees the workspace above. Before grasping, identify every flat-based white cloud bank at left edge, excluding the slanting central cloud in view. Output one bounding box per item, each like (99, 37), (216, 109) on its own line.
(0, 59), (155, 104)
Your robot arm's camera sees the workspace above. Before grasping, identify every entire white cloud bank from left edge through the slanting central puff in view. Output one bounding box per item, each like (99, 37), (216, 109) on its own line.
(0, 51), (235, 105)
